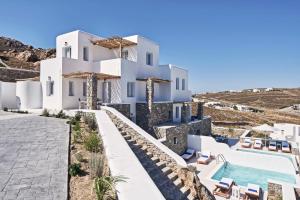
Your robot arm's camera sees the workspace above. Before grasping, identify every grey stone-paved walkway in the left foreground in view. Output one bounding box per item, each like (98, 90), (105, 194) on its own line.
(0, 116), (68, 200)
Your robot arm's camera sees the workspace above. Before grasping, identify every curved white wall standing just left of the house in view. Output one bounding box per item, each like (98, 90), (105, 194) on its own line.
(16, 81), (42, 110)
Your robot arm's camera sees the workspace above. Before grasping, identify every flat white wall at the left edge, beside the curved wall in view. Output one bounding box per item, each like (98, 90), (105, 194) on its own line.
(1, 82), (18, 109)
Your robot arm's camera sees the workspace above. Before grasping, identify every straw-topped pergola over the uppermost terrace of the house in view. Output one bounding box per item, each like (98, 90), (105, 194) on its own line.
(91, 36), (137, 58)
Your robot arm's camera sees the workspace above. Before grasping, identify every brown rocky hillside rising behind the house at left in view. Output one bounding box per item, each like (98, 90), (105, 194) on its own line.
(0, 37), (55, 70)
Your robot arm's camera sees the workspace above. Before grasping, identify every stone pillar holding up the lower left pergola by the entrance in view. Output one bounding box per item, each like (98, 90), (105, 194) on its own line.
(86, 73), (97, 110)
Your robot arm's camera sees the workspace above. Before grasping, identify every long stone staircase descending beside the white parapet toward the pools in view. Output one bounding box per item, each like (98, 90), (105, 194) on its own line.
(107, 111), (197, 200)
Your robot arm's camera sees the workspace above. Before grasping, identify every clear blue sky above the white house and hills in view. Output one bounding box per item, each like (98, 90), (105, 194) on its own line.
(0, 0), (300, 92)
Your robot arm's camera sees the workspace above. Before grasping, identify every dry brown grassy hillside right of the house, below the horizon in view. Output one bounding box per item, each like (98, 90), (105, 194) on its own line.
(196, 88), (300, 126)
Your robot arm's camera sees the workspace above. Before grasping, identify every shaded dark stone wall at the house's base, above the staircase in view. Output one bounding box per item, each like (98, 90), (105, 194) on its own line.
(136, 103), (173, 138)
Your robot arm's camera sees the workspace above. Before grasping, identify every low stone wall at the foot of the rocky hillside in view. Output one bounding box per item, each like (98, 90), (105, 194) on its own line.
(0, 68), (40, 82)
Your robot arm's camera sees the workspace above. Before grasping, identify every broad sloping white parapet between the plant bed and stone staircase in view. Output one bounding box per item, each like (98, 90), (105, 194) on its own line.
(94, 110), (165, 200)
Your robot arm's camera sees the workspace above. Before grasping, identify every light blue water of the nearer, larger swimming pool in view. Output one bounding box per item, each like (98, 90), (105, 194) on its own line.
(212, 163), (296, 191)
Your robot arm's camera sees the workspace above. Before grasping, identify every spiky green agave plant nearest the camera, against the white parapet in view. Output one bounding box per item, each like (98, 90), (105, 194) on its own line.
(95, 176), (126, 200)
